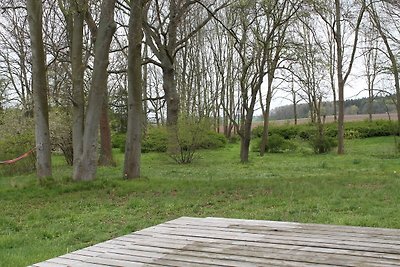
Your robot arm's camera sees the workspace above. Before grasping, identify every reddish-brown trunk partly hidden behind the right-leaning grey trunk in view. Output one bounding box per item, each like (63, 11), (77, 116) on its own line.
(99, 93), (116, 166)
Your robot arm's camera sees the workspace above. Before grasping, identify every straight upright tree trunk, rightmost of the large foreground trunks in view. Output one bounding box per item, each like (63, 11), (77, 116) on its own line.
(123, 0), (143, 179)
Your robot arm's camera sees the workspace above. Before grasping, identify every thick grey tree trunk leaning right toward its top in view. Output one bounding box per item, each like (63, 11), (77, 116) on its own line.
(74, 0), (116, 180)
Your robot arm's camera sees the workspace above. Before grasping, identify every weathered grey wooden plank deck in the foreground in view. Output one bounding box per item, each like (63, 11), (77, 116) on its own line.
(32, 217), (400, 267)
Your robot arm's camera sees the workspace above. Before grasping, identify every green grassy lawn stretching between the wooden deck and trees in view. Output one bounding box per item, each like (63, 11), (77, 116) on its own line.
(0, 137), (400, 266)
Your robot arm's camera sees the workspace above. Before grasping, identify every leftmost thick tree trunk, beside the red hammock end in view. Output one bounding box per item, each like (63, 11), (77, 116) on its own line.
(27, 0), (52, 179)
